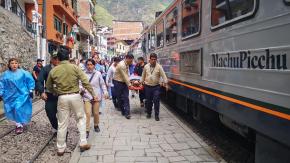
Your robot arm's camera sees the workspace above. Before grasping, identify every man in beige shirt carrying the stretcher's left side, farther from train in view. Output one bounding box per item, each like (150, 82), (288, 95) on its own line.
(113, 54), (134, 119)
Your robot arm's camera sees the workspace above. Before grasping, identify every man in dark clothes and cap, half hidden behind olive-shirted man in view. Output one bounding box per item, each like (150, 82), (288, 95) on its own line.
(37, 52), (59, 132)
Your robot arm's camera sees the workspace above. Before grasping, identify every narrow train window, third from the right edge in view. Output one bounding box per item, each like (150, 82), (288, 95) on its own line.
(166, 8), (178, 44)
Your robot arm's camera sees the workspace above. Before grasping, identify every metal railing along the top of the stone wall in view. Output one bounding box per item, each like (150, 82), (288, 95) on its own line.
(0, 0), (35, 35)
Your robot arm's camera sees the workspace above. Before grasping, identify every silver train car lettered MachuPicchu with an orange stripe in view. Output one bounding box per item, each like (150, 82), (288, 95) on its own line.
(142, 0), (290, 163)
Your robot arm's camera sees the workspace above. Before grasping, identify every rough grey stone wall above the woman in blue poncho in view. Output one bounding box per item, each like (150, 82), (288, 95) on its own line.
(0, 7), (37, 72)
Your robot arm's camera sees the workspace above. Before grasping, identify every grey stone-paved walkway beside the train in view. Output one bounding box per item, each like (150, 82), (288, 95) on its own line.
(71, 98), (220, 163)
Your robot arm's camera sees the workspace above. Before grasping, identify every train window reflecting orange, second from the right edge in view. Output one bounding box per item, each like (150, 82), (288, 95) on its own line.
(182, 0), (201, 38)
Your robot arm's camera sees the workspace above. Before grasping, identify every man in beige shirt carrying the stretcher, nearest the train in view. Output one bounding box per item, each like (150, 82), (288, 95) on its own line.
(141, 53), (168, 121)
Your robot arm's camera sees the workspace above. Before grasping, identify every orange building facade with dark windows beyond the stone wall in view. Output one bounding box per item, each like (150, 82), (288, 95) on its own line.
(25, 0), (78, 56)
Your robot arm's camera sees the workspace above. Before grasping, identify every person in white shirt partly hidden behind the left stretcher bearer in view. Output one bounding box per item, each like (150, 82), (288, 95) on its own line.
(106, 57), (120, 108)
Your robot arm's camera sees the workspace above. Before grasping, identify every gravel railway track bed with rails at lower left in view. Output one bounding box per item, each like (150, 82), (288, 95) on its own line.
(0, 100), (79, 163)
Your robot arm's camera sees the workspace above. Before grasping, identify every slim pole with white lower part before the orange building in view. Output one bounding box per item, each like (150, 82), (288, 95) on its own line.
(41, 0), (47, 65)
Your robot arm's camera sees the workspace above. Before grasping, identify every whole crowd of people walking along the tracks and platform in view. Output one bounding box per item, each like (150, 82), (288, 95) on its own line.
(0, 49), (168, 156)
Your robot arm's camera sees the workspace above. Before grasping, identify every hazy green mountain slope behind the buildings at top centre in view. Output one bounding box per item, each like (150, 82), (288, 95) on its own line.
(95, 0), (173, 26)
